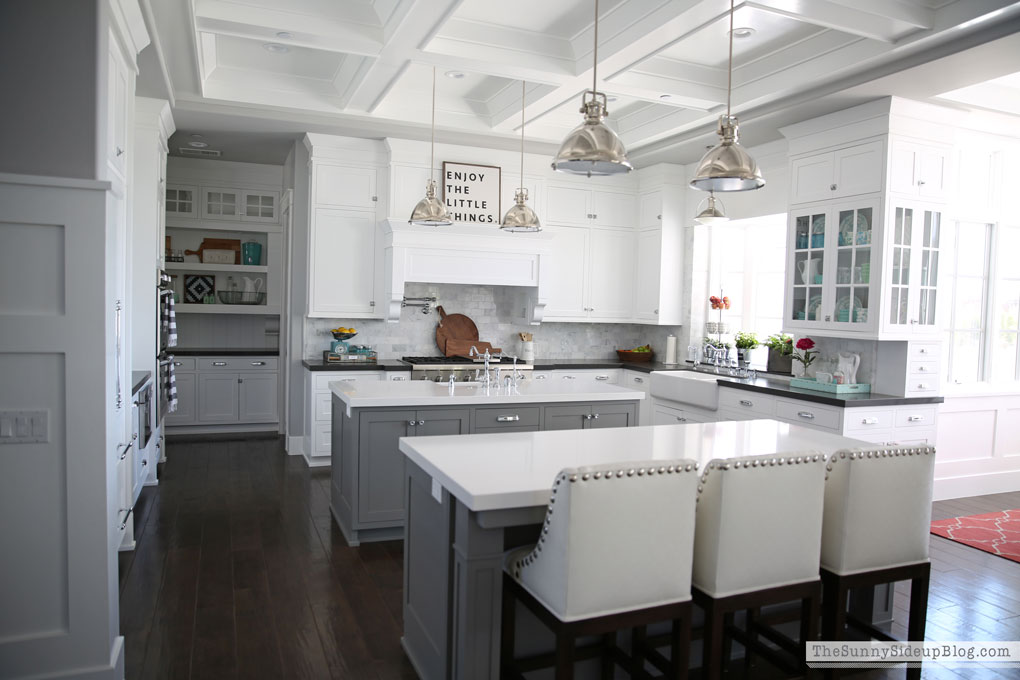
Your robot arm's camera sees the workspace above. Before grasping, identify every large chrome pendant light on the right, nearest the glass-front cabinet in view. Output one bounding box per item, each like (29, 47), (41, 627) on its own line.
(691, 0), (765, 192)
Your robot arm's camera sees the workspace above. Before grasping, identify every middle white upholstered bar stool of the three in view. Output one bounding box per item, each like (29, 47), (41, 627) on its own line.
(693, 452), (825, 680)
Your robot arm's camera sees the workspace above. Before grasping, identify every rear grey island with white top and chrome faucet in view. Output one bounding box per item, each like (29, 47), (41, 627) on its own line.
(329, 381), (645, 545)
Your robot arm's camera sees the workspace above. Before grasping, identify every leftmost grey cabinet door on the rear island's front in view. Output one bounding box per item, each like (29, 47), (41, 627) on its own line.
(355, 411), (417, 528)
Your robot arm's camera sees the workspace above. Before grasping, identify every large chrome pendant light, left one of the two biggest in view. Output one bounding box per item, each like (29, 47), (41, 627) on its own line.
(553, 0), (633, 177)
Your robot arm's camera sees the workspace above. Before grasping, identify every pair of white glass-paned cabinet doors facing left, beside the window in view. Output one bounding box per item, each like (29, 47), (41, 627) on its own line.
(784, 200), (881, 332)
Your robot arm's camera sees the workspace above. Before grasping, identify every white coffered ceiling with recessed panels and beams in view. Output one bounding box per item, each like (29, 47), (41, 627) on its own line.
(140, 0), (1020, 164)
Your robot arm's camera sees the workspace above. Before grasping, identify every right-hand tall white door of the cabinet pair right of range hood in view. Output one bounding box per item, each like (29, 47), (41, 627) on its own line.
(589, 229), (638, 320)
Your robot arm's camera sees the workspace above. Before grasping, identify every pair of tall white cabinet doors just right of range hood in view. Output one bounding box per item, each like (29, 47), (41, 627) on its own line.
(545, 225), (636, 321)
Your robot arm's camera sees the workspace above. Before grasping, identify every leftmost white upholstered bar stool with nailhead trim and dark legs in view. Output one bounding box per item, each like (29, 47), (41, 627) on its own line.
(500, 460), (698, 679)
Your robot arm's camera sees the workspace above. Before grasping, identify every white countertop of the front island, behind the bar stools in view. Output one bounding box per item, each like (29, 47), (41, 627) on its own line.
(400, 420), (873, 511)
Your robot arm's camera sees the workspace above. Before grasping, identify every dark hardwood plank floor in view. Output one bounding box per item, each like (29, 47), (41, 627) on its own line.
(120, 438), (1020, 680)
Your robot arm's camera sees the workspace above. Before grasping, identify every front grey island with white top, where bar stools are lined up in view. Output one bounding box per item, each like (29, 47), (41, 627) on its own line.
(400, 420), (866, 680)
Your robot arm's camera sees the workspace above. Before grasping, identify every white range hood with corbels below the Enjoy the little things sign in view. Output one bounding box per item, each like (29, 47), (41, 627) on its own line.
(376, 219), (553, 323)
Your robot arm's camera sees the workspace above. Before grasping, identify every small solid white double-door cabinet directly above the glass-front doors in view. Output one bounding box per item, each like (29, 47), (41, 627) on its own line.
(789, 140), (884, 204)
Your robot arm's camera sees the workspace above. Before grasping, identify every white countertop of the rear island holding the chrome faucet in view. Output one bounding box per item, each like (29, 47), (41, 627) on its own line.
(329, 380), (645, 415)
